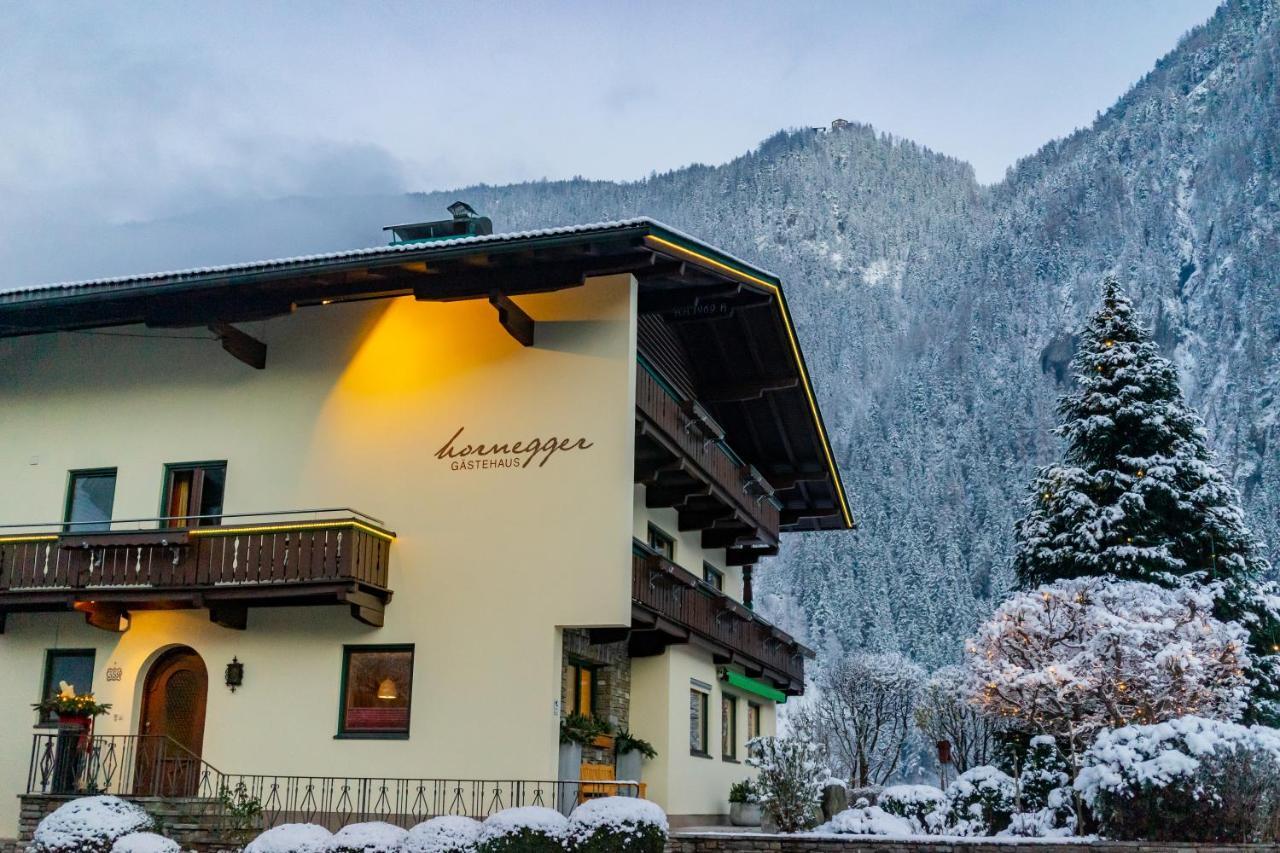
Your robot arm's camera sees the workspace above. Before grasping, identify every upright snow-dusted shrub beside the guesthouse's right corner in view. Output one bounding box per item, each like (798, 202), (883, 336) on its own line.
(746, 738), (829, 833)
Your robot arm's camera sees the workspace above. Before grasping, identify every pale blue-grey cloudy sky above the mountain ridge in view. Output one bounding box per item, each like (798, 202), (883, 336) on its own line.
(0, 0), (1216, 233)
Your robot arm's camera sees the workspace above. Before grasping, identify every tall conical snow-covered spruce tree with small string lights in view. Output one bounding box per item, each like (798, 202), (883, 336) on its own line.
(1014, 279), (1280, 725)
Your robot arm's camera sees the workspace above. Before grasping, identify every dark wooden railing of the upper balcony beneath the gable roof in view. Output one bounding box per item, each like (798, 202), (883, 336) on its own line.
(636, 364), (781, 547)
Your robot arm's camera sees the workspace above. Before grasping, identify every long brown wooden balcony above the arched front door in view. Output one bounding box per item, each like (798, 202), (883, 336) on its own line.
(0, 515), (396, 630)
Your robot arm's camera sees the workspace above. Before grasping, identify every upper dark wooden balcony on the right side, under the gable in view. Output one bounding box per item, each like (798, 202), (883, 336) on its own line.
(636, 364), (781, 550)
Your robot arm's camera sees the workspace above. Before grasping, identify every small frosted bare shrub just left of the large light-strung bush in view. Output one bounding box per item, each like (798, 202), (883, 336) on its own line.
(915, 666), (1006, 774)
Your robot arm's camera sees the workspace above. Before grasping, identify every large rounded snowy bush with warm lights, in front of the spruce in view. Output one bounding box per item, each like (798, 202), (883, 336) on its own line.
(966, 578), (1249, 749)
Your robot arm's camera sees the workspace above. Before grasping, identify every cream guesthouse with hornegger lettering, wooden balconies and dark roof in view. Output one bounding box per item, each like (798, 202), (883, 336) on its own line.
(0, 211), (852, 836)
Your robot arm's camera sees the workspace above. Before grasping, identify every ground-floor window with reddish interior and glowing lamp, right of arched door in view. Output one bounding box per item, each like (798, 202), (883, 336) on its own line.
(338, 646), (413, 738)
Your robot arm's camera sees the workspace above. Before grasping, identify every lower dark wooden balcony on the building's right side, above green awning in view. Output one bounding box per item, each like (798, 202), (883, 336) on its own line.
(630, 542), (813, 695)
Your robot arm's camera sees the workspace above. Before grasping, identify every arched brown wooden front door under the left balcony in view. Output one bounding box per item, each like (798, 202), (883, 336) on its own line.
(134, 647), (209, 797)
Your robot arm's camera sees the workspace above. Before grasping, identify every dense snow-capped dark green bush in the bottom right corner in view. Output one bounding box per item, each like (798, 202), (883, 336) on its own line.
(1075, 717), (1280, 841)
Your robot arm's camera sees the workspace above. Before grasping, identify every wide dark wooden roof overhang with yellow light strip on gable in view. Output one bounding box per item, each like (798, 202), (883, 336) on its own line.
(0, 219), (854, 530)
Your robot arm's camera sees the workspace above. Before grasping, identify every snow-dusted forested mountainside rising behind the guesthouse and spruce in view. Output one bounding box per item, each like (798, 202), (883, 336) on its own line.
(5, 0), (1280, 666)
